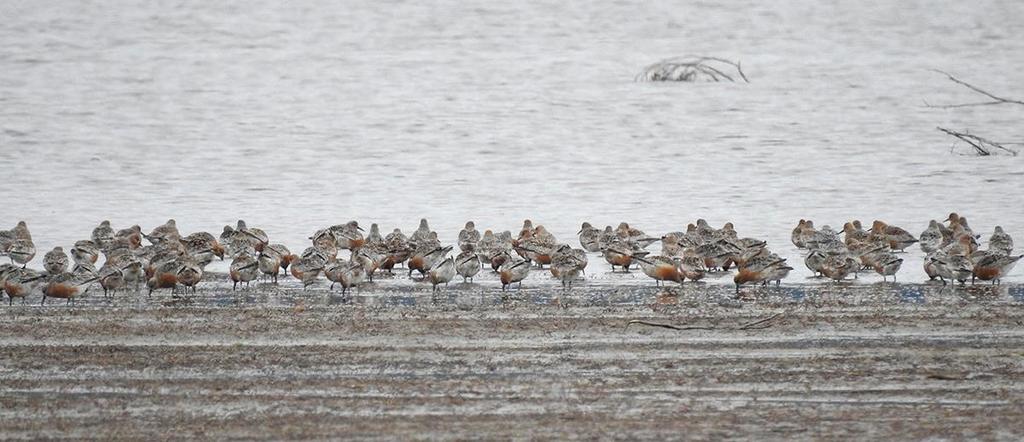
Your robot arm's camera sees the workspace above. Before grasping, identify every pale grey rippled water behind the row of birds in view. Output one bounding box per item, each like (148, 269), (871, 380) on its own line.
(0, 0), (1024, 282)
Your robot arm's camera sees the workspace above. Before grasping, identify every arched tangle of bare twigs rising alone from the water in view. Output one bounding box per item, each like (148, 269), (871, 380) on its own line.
(636, 55), (751, 83)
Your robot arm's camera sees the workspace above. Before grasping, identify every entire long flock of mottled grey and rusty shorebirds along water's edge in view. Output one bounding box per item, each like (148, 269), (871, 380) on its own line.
(0, 213), (1021, 304)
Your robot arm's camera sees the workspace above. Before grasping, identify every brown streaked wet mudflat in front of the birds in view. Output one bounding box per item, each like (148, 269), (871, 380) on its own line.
(0, 275), (1024, 439)
